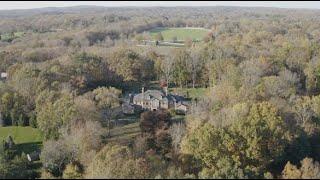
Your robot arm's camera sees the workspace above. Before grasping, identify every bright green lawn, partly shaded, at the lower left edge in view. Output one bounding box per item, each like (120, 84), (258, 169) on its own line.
(0, 126), (43, 153)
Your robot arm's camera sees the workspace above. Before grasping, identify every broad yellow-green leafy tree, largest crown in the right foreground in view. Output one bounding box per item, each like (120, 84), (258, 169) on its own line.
(182, 102), (287, 177)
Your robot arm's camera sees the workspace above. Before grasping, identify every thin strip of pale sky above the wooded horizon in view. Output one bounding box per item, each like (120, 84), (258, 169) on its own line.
(0, 1), (320, 10)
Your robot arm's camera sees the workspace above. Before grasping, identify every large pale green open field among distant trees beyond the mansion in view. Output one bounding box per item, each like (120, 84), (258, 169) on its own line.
(150, 28), (210, 41)
